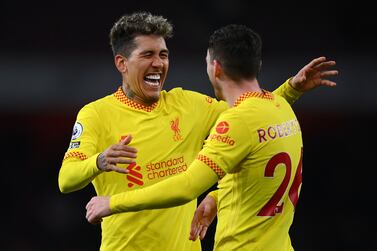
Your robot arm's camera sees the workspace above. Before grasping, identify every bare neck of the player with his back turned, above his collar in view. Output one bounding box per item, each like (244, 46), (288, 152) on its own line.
(222, 79), (262, 107)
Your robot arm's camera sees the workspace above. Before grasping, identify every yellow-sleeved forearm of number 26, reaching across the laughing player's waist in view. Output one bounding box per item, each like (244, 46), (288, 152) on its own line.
(110, 160), (218, 213)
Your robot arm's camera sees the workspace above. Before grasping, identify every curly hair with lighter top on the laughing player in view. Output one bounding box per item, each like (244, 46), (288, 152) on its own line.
(110, 12), (173, 57)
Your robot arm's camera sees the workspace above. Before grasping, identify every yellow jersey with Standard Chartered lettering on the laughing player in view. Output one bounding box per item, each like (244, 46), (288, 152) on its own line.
(59, 88), (228, 251)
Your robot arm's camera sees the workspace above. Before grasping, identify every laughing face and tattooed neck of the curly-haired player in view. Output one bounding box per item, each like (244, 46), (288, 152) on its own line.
(119, 35), (169, 105)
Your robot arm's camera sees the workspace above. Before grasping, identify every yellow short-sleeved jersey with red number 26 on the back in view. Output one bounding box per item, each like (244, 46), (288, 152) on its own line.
(198, 92), (302, 251)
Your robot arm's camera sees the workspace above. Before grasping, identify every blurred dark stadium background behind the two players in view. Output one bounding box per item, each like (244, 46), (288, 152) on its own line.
(0, 0), (377, 251)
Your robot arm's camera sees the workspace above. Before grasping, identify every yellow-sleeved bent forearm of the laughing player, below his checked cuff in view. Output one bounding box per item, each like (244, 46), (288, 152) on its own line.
(58, 154), (102, 193)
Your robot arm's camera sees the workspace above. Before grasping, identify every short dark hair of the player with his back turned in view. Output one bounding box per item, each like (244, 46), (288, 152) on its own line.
(208, 24), (262, 81)
